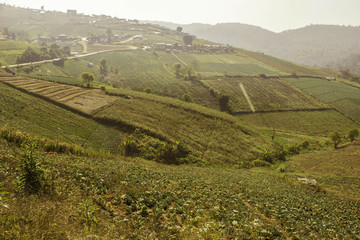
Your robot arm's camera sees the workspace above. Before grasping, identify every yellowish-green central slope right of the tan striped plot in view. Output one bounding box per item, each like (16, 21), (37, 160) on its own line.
(94, 90), (267, 164)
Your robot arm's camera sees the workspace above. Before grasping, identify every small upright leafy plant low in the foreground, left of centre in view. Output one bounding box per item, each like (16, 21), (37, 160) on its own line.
(78, 201), (98, 231)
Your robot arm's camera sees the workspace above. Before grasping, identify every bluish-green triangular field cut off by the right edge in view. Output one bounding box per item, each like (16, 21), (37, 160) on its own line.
(287, 78), (360, 123)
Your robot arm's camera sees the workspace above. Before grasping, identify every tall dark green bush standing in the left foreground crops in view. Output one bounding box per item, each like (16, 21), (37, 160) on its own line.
(18, 139), (45, 194)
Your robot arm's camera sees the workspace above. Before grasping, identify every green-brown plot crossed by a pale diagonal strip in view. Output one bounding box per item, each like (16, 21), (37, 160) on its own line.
(203, 77), (326, 112)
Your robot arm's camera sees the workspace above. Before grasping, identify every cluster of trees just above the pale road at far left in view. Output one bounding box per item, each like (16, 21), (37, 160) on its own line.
(16, 43), (71, 64)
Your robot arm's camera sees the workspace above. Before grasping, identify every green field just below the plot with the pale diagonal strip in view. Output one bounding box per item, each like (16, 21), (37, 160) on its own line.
(238, 110), (360, 137)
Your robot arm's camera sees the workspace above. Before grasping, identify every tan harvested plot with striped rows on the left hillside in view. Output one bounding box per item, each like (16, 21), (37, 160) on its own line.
(1, 77), (116, 114)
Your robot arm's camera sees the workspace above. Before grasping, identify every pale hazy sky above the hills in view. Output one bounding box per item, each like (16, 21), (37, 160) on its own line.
(0, 0), (360, 32)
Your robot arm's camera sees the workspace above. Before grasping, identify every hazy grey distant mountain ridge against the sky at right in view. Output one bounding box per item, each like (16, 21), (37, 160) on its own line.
(143, 21), (360, 72)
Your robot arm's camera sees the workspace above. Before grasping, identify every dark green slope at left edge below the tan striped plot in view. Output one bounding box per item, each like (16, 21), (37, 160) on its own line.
(0, 83), (121, 151)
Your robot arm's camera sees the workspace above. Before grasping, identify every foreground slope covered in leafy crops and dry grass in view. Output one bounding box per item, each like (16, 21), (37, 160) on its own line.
(0, 139), (360, 239)
